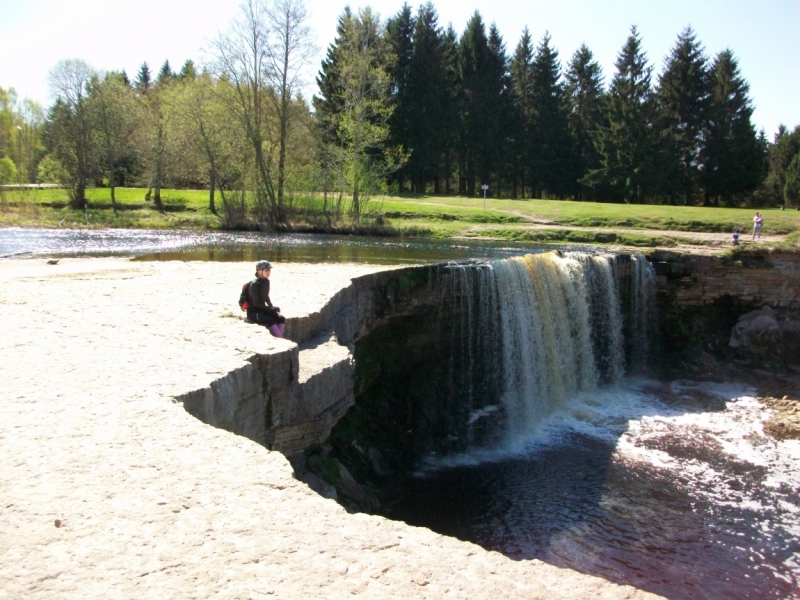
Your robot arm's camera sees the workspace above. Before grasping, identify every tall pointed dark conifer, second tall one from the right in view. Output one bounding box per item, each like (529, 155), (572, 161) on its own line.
(657, 27), (709, 205)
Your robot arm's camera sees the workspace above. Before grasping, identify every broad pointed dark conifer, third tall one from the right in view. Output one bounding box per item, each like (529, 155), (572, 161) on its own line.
(582, 27), (657, 203)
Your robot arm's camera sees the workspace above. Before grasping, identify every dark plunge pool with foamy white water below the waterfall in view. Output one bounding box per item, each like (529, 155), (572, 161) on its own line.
(393, 381), (800, 600)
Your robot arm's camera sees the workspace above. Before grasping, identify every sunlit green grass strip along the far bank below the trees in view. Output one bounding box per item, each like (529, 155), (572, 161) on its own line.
(0, 183), (800, 247)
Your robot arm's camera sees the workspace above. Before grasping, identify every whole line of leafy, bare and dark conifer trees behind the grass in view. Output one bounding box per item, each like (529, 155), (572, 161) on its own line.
(0, 0), (800, 225)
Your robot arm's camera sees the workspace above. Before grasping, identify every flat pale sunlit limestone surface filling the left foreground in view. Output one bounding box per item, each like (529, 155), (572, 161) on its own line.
(0, 259), (653, 599)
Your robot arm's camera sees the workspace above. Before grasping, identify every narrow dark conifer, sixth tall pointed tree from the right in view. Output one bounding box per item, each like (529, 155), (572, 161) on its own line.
(509, 27), (533, 198)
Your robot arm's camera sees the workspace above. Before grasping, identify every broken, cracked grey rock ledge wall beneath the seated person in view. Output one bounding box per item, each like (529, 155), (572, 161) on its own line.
(177, 267), (438, 454)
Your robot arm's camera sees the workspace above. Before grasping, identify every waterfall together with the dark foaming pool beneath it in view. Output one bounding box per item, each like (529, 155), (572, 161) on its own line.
(392, 253), (800, 599)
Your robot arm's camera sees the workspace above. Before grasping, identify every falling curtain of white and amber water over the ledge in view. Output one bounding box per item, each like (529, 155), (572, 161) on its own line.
(438, 252), (655, 443)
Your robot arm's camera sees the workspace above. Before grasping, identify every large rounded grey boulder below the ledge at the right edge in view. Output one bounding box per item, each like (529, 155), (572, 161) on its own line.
(728, 307), (800, 368)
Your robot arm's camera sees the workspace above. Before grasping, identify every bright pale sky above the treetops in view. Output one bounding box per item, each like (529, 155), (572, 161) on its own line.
(0, 0), (800, 139)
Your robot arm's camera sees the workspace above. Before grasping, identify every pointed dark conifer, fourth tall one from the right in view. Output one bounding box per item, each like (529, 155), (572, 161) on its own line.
(564, 44), (603, 199)
